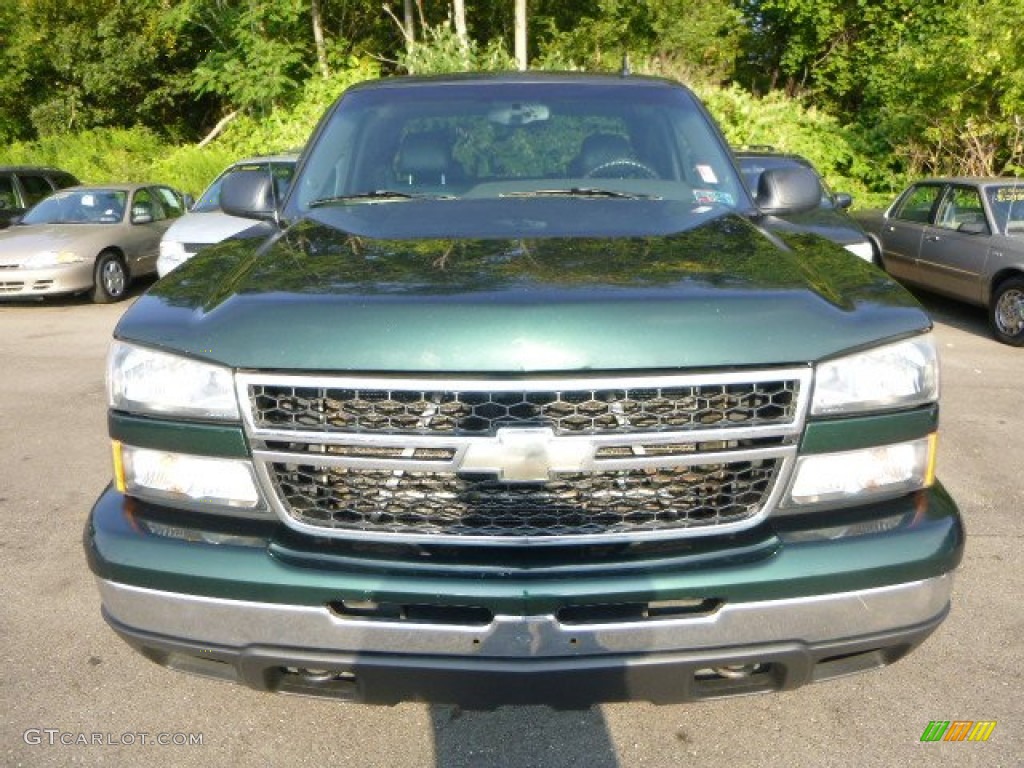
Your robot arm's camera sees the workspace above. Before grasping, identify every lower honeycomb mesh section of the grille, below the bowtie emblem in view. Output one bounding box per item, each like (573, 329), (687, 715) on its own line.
(270, 459), (779, 537)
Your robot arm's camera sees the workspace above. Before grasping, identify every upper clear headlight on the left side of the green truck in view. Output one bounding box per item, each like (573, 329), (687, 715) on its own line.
(106, 341), (241, 421)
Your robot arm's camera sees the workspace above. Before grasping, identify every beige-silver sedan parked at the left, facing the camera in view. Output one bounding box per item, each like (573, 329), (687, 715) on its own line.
(0, 184), (185, 303)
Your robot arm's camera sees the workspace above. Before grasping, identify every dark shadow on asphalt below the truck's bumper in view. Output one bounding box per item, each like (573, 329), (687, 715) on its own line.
(430, 706), (620, 768)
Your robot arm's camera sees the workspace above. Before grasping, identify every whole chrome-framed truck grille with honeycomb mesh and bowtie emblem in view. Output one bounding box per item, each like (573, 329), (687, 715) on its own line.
(238, 369), (810, 544)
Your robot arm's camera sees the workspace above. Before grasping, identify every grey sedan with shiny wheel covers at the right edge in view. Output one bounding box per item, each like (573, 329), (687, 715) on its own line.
(861, 177), (1024, 346)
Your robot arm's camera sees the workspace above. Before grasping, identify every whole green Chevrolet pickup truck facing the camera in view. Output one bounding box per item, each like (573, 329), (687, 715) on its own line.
(85, 73), (964, 709)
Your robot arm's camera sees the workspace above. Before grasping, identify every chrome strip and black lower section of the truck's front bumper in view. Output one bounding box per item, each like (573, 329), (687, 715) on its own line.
(99, 575), (952, 709)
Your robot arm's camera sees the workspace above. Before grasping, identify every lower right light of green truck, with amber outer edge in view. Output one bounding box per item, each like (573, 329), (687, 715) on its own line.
(783, 434), (936, 508)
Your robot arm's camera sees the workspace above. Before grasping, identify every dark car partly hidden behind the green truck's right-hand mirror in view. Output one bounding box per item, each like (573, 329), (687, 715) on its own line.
(735, 147), (876, 261)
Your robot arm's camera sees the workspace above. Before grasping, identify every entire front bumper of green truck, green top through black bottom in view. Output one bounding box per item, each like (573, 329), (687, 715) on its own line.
(86, 487), (964, 709)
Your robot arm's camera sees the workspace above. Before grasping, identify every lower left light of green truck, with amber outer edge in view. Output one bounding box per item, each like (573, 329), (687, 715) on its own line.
(114, 441), (262, 510)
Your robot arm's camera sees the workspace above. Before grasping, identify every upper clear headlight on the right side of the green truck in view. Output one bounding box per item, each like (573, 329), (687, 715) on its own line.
(811, 334), (939, 416)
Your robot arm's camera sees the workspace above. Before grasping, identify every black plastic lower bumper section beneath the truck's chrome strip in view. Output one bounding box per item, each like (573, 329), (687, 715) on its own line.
(104, 613), (945, 710)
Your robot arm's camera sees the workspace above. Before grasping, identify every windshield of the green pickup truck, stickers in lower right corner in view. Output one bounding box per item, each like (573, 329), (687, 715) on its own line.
(289, 80), (750, 229)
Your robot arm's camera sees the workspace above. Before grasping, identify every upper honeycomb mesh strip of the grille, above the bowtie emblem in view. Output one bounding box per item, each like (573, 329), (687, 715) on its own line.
(249, 380), (799, 435)
